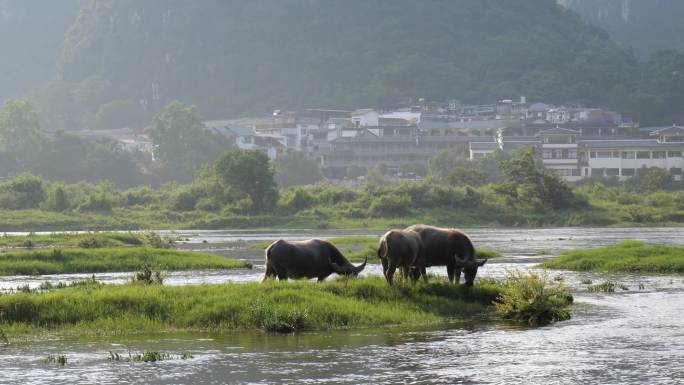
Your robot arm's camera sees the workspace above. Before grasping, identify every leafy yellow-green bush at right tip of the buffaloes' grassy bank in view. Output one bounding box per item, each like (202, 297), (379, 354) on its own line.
(494, 270), (573, 326)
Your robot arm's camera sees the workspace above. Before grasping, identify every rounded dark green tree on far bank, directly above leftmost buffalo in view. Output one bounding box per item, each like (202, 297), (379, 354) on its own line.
(216, 150), (278, 213)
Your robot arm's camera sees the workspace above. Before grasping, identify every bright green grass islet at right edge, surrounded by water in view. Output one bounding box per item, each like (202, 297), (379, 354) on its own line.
(541, 241), (684, 274)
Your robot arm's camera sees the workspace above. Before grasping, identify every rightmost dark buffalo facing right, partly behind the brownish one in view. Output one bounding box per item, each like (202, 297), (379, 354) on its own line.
(406, 225), (487, 286)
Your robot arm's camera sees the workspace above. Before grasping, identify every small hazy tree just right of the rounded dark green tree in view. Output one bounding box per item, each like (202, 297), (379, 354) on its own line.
(274, 151), (321, 187)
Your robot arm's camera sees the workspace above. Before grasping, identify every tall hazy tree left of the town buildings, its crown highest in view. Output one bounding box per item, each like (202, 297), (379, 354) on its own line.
(147, 101), (230, 181)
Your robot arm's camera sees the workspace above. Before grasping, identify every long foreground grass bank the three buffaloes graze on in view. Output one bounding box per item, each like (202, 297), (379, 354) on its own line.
(0, 277), (502, 335)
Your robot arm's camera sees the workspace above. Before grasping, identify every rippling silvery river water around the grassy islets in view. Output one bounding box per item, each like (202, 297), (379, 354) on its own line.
(0, 228), (684, 384)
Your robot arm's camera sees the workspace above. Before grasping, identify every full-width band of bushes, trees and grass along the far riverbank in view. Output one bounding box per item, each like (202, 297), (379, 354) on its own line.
(0, 149), (684, 231)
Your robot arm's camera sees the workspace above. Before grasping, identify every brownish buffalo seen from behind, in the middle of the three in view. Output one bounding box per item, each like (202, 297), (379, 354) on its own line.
(378, 230), (427, 285)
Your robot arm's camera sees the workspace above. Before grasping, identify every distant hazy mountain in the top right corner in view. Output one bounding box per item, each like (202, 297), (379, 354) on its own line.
(560, 0), (684, 57)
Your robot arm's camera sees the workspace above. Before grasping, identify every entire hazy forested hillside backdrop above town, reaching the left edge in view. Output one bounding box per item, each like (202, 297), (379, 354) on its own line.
(0, 0), (684, 131)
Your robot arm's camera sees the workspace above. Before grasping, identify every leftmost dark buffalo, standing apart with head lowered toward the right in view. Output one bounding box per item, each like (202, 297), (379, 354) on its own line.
(264, 239), (368, 281)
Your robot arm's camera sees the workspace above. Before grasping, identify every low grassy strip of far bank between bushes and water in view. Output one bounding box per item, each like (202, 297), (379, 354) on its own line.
(0, 198), (684, 232)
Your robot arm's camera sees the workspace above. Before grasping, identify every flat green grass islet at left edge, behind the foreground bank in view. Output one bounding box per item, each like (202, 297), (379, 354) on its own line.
(0, 247), (249, 275)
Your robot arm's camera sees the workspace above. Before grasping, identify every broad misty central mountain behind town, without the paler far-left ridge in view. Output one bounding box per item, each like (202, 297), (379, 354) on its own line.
(58, 0), (637, 121)
